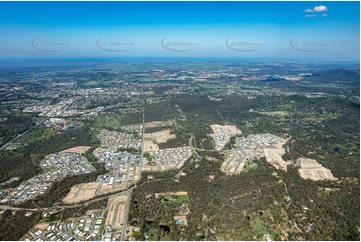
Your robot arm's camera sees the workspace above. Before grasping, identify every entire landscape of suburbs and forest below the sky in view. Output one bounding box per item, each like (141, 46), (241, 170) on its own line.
(0, 59), (360, 241)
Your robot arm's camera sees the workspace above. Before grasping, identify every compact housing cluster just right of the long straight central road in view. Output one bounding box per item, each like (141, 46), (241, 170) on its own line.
(150, 146), (192, 166)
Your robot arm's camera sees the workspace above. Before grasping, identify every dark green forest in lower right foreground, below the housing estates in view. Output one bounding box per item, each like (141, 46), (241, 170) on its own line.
(129, 152), (359, 240)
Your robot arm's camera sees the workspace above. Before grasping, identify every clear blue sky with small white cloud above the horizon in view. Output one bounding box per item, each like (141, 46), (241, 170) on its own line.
(0, 1), (360, 59)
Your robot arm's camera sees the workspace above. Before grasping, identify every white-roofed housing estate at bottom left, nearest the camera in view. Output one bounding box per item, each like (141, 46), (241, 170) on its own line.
(21, 210), (106, 241)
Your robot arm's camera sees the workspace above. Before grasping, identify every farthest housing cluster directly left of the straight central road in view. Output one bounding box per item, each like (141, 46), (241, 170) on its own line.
(98, 129), (142, 151)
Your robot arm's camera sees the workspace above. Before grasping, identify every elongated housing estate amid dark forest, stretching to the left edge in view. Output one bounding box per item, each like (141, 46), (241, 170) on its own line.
(0, 152), (95, 204)
